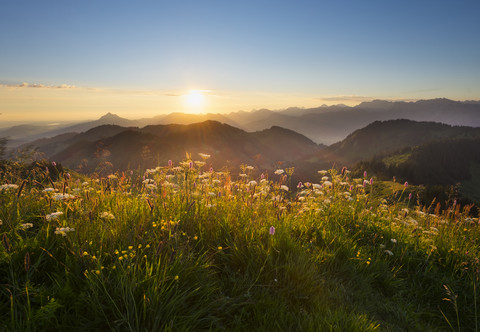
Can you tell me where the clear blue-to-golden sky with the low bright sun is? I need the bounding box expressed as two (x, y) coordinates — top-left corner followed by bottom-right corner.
(0, 0), (480, 123)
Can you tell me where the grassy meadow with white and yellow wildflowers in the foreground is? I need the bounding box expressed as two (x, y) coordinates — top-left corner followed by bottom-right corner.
(0, 154), (480, 331)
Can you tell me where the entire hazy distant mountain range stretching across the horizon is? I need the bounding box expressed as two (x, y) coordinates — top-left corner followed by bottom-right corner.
(0, 99), (480, 147)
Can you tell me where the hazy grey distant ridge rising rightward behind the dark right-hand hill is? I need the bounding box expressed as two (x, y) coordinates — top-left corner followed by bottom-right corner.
(242, 99), (480, 144)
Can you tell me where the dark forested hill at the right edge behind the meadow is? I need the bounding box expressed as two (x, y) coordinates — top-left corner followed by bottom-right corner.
(322, 120), (480, 204)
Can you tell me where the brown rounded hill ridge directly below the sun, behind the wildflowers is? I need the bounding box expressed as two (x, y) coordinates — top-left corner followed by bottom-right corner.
(35, 121), (321, 171)
